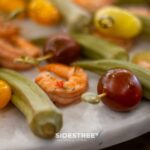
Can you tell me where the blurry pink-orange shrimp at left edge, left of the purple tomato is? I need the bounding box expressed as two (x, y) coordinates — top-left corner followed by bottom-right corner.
(0, 36), (41, 70)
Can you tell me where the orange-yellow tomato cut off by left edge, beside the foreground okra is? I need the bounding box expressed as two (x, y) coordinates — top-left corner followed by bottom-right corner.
(0, 80), (11, 109)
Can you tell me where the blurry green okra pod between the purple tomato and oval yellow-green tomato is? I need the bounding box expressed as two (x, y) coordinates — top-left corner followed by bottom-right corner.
(71, 33), (128, 60)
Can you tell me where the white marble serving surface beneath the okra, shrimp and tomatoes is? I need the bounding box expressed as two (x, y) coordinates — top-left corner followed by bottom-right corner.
(0, 20), (150, 150)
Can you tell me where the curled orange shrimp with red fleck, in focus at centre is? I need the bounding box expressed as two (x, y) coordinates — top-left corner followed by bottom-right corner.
(35, 64), (88, 106)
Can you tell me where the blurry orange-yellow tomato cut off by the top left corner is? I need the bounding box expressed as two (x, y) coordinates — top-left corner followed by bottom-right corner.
(0, 0), (26, 13)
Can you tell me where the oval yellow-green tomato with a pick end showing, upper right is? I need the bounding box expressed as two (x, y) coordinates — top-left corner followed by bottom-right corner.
(94, 6), (142, 38)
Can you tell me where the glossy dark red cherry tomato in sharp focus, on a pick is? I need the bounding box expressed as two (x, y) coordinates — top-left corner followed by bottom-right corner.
(97, 69), (142, 111)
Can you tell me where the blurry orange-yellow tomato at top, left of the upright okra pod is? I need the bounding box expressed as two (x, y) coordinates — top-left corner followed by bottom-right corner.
(28, 0), (60, 25)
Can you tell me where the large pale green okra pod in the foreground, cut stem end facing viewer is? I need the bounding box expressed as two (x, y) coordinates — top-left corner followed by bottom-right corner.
(0, 69), (62, 138)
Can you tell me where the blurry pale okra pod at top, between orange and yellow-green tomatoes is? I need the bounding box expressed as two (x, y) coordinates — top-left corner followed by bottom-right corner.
(50, 0), (92, 31)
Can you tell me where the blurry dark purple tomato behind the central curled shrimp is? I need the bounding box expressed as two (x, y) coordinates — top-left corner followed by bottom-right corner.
(44, 34), (80, 64)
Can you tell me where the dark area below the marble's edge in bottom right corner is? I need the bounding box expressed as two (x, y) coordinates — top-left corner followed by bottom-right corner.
(103, 133), (150, 150)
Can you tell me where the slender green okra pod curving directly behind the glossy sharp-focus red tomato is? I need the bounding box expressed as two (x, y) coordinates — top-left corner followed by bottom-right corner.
(74, 60), (150, 100)
